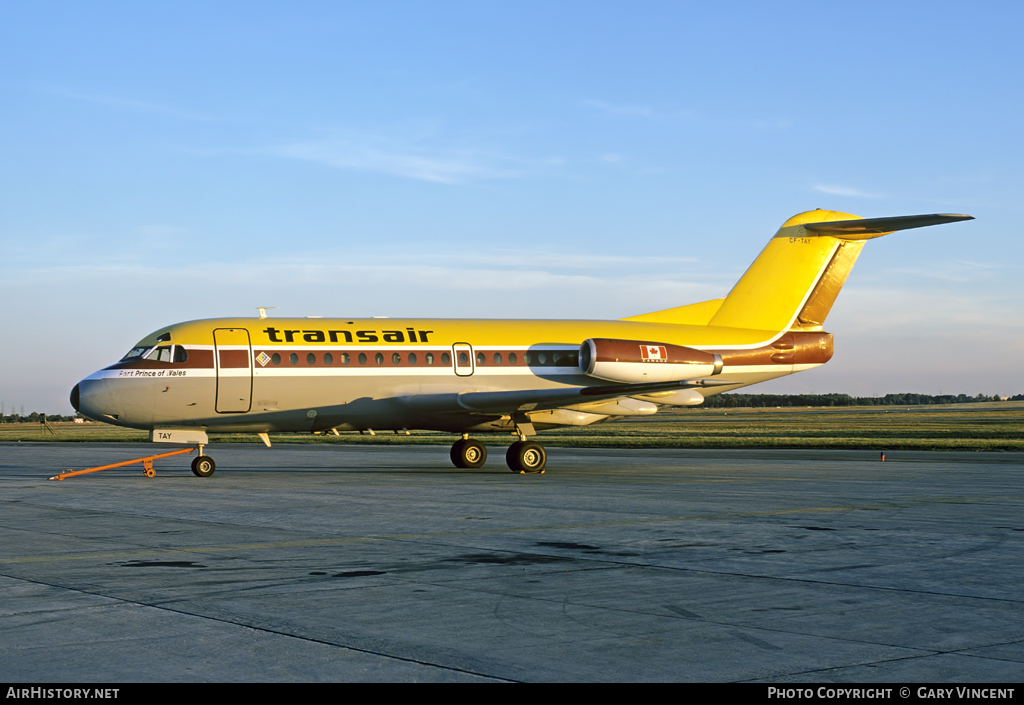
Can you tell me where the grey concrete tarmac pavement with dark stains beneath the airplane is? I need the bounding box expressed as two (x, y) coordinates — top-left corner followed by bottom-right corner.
(0, 443), (1024, 683)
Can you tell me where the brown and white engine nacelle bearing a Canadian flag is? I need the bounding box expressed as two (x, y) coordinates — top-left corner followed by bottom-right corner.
(580, 338), (722, 382)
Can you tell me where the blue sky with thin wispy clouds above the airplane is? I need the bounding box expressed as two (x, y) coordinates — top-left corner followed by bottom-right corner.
(0, 0), (1024, 413)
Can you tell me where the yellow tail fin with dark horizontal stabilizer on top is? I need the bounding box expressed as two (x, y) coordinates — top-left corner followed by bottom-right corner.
(708, 210), (973, 333)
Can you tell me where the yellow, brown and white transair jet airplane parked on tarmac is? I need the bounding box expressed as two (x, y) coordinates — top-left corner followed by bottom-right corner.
(71, 209), (973, 478)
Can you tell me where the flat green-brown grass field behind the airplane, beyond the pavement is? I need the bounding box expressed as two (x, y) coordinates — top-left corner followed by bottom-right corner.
(0, 402), (1024, 451)
